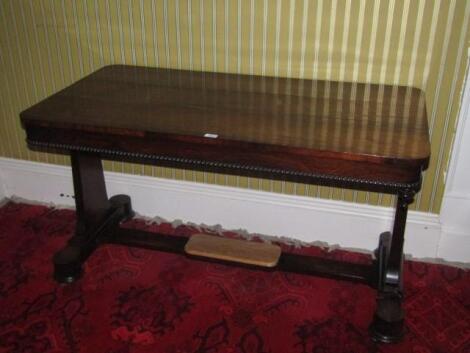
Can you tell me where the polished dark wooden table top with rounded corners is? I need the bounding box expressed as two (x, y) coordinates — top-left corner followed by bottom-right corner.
(21, 65), (430, 187)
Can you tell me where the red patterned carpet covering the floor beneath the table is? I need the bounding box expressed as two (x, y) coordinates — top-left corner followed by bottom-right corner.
(0, 203), (470, 353)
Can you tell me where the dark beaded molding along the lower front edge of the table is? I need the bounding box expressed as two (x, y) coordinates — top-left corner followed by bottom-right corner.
(26, 139), (421, 193)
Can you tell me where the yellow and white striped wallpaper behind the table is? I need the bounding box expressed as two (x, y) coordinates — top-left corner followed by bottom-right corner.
(0, 0), (470, 213)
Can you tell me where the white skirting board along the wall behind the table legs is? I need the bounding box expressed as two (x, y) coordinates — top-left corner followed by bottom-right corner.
(0, 158), (470, 262)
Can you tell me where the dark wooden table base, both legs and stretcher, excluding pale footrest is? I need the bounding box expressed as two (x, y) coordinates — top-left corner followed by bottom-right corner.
(54, 151), (416, 342)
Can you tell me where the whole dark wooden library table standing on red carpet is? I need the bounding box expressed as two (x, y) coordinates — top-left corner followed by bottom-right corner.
(20, 65), (430, 342)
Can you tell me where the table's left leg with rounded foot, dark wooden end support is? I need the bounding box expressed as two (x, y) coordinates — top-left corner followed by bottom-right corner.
(53, 151), (133, 283)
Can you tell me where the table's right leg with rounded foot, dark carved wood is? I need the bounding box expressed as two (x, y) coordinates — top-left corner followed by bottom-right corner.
(369, 190), (414, 342)
